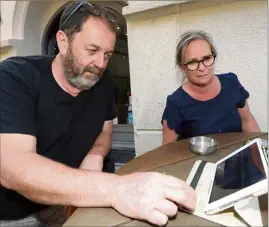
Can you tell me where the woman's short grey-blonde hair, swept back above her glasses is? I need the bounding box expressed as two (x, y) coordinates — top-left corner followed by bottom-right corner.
(176, 30), (217, 67)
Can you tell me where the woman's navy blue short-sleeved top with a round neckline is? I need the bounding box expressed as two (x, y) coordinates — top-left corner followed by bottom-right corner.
(162, 73), (249, 138)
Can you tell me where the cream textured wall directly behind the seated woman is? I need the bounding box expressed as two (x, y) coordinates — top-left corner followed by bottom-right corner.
(124, 1), (267, 155)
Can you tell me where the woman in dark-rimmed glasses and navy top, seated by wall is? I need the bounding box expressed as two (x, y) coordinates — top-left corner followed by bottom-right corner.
(162, 31), (260, 144)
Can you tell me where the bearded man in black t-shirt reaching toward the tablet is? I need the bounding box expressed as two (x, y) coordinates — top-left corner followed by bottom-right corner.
(0, 1), (196, 226)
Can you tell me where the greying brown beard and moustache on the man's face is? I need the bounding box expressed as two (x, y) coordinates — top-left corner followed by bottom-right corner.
(63, 46), (103, 91)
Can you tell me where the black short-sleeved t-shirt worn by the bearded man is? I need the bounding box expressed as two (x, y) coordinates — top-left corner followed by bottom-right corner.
(0, 56), (116, 220)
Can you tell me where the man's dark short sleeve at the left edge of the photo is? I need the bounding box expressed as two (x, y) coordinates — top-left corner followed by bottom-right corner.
(0, 62), (36, 136)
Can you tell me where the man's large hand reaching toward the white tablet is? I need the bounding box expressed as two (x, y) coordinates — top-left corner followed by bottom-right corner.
(112, 172), (196, 225)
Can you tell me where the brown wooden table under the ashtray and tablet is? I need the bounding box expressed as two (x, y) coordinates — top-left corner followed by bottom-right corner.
(64, 133), (268, 226)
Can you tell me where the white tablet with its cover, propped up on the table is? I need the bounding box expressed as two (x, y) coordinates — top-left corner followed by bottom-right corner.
(187, 139), (268, 214)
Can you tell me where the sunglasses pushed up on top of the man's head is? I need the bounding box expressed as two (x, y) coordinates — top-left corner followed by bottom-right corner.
(60, 1), (117, 30)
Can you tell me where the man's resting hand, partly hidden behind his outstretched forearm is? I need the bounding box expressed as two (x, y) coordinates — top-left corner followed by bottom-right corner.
(79, 153), (104, 172)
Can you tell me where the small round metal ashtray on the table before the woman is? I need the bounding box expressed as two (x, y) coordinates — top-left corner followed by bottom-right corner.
(189, 136), (217, 155)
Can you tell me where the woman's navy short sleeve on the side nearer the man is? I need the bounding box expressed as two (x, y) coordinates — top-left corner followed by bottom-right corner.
(162, 96), (182, 135)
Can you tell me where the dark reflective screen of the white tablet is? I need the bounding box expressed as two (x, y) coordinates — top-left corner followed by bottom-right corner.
(209, 143), (266, 203)
